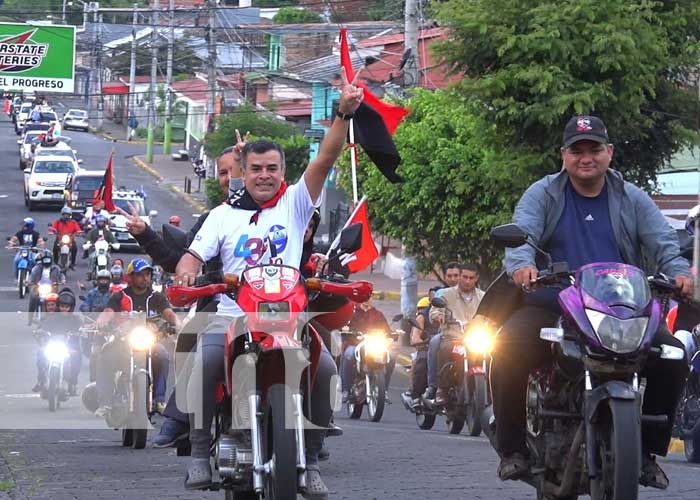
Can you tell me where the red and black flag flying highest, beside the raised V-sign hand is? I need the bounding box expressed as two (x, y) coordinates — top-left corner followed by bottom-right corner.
(340, 28), (409, 182)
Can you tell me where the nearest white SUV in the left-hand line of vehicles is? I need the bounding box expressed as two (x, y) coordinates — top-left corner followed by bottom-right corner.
(24, 156), (79, 210)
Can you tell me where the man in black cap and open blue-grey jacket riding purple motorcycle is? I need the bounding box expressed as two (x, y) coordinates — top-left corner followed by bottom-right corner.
(491, 116), (692, 489)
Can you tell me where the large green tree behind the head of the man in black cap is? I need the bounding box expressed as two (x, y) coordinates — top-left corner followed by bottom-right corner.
(436, 0), (700, 185)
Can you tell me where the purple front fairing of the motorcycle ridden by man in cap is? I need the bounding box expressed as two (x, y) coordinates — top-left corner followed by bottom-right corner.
(558, 262), (661, 357)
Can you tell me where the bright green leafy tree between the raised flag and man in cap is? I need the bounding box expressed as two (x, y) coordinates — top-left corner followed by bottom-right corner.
(339, 90), (526, 272)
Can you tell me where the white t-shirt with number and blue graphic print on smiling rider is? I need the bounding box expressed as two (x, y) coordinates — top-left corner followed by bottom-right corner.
(190, 178), (323, 316)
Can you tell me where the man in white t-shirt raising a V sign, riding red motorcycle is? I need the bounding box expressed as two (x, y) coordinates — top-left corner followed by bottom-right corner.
(175, 67), (363, 499)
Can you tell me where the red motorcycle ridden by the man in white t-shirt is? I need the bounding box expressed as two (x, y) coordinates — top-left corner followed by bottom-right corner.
(167, 227), (372, 500)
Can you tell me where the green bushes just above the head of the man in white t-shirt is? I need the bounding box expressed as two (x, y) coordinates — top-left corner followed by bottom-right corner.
(204, 104), (297, 157)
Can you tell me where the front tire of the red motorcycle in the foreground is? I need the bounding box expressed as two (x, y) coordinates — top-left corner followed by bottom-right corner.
(262, 384), (298, 500)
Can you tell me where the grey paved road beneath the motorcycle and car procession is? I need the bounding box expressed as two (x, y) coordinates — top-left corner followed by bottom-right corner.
(0, 113), (700, 500)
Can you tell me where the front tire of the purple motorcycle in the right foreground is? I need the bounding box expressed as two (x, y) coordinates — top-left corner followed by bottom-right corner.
(590, 399), (642, 500)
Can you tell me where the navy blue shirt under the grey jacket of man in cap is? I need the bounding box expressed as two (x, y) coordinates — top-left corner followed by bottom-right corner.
(545, 182), (623, 271)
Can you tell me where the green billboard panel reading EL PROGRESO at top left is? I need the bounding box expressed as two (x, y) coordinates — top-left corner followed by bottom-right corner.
(0, 23), (75, 93)
